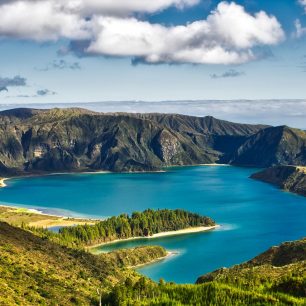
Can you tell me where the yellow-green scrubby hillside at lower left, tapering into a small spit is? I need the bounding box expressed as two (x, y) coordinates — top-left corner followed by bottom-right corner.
(0, 222), (166, 306)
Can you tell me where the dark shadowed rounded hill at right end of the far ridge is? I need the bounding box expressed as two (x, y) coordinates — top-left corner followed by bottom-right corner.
(229, 126), (306, 167)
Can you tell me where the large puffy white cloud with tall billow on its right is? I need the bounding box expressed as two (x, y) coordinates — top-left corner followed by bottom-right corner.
(87, 2), (284, 64)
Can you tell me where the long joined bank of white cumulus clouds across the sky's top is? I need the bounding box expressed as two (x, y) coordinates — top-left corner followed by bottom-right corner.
(0, 0), (284, 64)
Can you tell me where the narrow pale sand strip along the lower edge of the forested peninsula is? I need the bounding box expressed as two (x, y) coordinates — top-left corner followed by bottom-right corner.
(87, 225), (220, 249)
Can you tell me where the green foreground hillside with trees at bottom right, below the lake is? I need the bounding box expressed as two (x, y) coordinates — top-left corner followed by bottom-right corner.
(103, 239), (306, 306)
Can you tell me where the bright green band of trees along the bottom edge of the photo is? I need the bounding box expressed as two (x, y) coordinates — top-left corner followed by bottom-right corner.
(103, 276), (306, 306)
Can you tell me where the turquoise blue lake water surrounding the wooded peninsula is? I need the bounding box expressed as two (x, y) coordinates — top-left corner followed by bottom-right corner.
(0, 166), (306, 283)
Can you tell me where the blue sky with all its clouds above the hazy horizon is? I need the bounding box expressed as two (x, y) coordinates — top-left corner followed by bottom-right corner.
(0, 0), (306, 104)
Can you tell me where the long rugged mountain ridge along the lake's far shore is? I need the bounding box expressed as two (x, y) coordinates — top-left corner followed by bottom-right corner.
(0, 108), (306, 176)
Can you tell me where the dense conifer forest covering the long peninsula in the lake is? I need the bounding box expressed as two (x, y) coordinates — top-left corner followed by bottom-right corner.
(54, 209), (215, 246)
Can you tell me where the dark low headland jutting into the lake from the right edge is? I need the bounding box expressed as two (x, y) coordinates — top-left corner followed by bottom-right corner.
(251, 166), (306, 196)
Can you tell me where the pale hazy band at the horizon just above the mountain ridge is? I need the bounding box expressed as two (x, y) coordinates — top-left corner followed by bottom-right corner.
(0, 99), (306, 129)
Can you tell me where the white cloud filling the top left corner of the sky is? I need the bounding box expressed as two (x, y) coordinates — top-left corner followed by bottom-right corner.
(0, 1), (90, 41)
